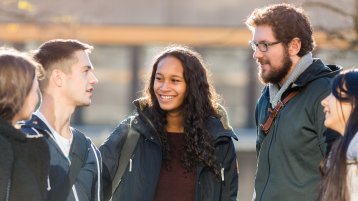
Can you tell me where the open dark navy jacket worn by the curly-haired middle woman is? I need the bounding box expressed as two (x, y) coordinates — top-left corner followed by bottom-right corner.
(99, 101), (238, 201)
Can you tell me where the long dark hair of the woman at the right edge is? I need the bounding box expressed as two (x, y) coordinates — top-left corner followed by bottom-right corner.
(317, 69), (358, 201)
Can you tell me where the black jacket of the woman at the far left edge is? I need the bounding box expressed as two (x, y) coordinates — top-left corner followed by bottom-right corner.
(0, 119), (50, 201)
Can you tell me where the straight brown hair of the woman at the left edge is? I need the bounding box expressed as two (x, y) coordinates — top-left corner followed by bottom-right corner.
(0, 47), (43, 122)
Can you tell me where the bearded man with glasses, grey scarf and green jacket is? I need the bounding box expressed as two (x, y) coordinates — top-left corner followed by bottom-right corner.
(246, 4), (341, 201)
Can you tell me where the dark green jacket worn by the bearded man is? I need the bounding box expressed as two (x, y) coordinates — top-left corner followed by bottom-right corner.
(253, 59), (341, 201)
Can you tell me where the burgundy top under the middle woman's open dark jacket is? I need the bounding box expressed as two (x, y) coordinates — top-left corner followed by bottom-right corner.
(154, 133), (195, 201)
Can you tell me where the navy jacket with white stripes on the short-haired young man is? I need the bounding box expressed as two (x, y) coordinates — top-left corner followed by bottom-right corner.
(21, 114), (102, 201)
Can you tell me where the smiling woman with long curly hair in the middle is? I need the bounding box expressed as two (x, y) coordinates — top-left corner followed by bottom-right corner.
(100, 46), (238, 201)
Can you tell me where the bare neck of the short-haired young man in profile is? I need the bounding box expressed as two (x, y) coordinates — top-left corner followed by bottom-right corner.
(39, 95), (75, 139)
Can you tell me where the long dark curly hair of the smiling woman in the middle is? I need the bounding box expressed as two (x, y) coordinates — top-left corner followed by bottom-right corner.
(140, 46), (220, 177)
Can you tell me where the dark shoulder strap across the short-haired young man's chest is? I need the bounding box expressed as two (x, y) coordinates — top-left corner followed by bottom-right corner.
(49, 129), (90, 201)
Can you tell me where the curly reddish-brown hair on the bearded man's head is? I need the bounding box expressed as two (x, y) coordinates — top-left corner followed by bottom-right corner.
(246, 4), (315, 57)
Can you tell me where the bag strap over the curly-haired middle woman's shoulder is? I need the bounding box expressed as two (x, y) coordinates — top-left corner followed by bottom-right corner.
(112, 118), (140, 196)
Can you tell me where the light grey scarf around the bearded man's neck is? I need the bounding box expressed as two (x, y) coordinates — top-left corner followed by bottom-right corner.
(268, 52), (313, 108)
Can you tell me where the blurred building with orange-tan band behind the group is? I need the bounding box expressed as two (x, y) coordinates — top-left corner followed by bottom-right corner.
(0, 0), (358, 201)
